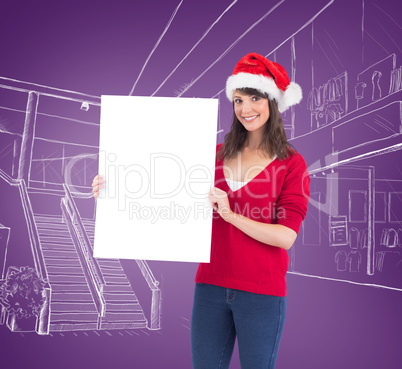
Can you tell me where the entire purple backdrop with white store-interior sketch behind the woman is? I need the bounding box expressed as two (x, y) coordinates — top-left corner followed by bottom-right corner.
(0, 0), (402, 369)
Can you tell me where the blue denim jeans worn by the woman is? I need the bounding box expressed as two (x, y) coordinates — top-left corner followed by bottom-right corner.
(191, 283), (286, 369)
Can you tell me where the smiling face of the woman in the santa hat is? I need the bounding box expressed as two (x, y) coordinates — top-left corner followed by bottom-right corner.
(233, 90), (269, 132)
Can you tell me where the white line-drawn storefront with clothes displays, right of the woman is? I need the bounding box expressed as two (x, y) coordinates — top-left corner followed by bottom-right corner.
(291, 54), (402, 291)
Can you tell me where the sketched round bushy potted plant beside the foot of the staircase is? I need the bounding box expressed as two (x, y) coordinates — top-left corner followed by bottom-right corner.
(0, 267), (45, 332)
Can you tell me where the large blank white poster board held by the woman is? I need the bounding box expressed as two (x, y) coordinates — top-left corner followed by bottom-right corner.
(94, 96), (218, 262)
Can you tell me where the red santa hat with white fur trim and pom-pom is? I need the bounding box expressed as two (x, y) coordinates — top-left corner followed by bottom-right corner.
(226, 53), (302, 113)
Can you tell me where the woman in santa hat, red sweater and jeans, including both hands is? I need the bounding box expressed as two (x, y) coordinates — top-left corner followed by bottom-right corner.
(92, 53), (310, 369)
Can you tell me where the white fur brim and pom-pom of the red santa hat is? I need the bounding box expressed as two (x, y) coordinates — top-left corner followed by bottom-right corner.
(226, 73), (302, 113)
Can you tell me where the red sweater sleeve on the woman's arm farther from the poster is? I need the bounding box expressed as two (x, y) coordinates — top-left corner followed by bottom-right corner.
(276, 154), (310, 233)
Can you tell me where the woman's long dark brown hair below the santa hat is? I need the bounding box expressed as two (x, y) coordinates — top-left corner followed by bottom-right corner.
(218, 88), (296, 160)
